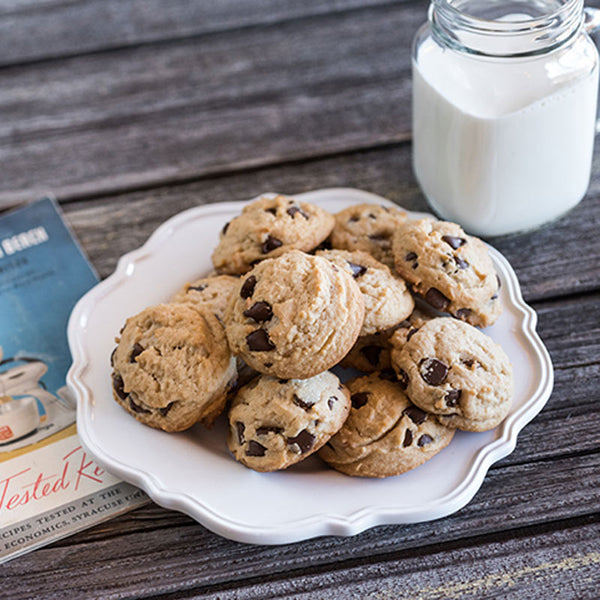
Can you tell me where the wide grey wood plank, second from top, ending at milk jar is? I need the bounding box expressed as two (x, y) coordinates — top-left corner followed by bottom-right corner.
(0, 3), (425, 206)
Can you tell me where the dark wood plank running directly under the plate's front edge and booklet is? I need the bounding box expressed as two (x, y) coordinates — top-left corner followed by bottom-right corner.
(0, 455), (600, 599)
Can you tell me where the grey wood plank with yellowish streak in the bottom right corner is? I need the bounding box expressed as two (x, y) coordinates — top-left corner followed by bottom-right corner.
(168, 522), (600, 600)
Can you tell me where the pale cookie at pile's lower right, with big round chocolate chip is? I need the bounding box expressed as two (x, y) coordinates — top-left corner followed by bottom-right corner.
(392, 318), (513, 431)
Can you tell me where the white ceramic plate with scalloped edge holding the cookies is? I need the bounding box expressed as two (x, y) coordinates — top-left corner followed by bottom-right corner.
(68, 188), (553, 544)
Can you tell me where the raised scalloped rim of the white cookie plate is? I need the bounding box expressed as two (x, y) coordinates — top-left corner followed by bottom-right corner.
(67, 187), (554, 544)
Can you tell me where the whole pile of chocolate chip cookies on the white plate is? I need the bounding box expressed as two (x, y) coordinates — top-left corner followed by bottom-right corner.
(111, 196), (512, 477)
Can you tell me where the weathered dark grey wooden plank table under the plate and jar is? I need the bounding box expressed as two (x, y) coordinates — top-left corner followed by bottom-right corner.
(0, 0), (600, 600)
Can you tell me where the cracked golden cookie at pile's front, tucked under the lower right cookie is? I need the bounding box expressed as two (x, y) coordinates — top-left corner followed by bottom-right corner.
(319, 373), (454, 477)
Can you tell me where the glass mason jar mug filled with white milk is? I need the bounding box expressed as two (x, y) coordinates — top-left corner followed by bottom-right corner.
(413, 0), (599, 235)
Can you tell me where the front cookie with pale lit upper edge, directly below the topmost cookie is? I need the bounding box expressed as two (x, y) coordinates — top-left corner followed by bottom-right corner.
(227, 371), (350, 471)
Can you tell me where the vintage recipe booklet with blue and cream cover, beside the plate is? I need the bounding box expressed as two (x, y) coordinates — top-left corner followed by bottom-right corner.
(0, 198), (148, 562)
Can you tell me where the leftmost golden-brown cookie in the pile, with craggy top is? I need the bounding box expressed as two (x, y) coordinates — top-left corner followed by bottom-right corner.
(111, 304), (236, 431)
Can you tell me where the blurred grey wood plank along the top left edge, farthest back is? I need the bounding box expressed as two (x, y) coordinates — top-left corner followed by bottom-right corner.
(0, 0), (414, 67)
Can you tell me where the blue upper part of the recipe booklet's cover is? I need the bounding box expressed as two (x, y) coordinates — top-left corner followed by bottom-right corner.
(0, 198), (98, 408)
